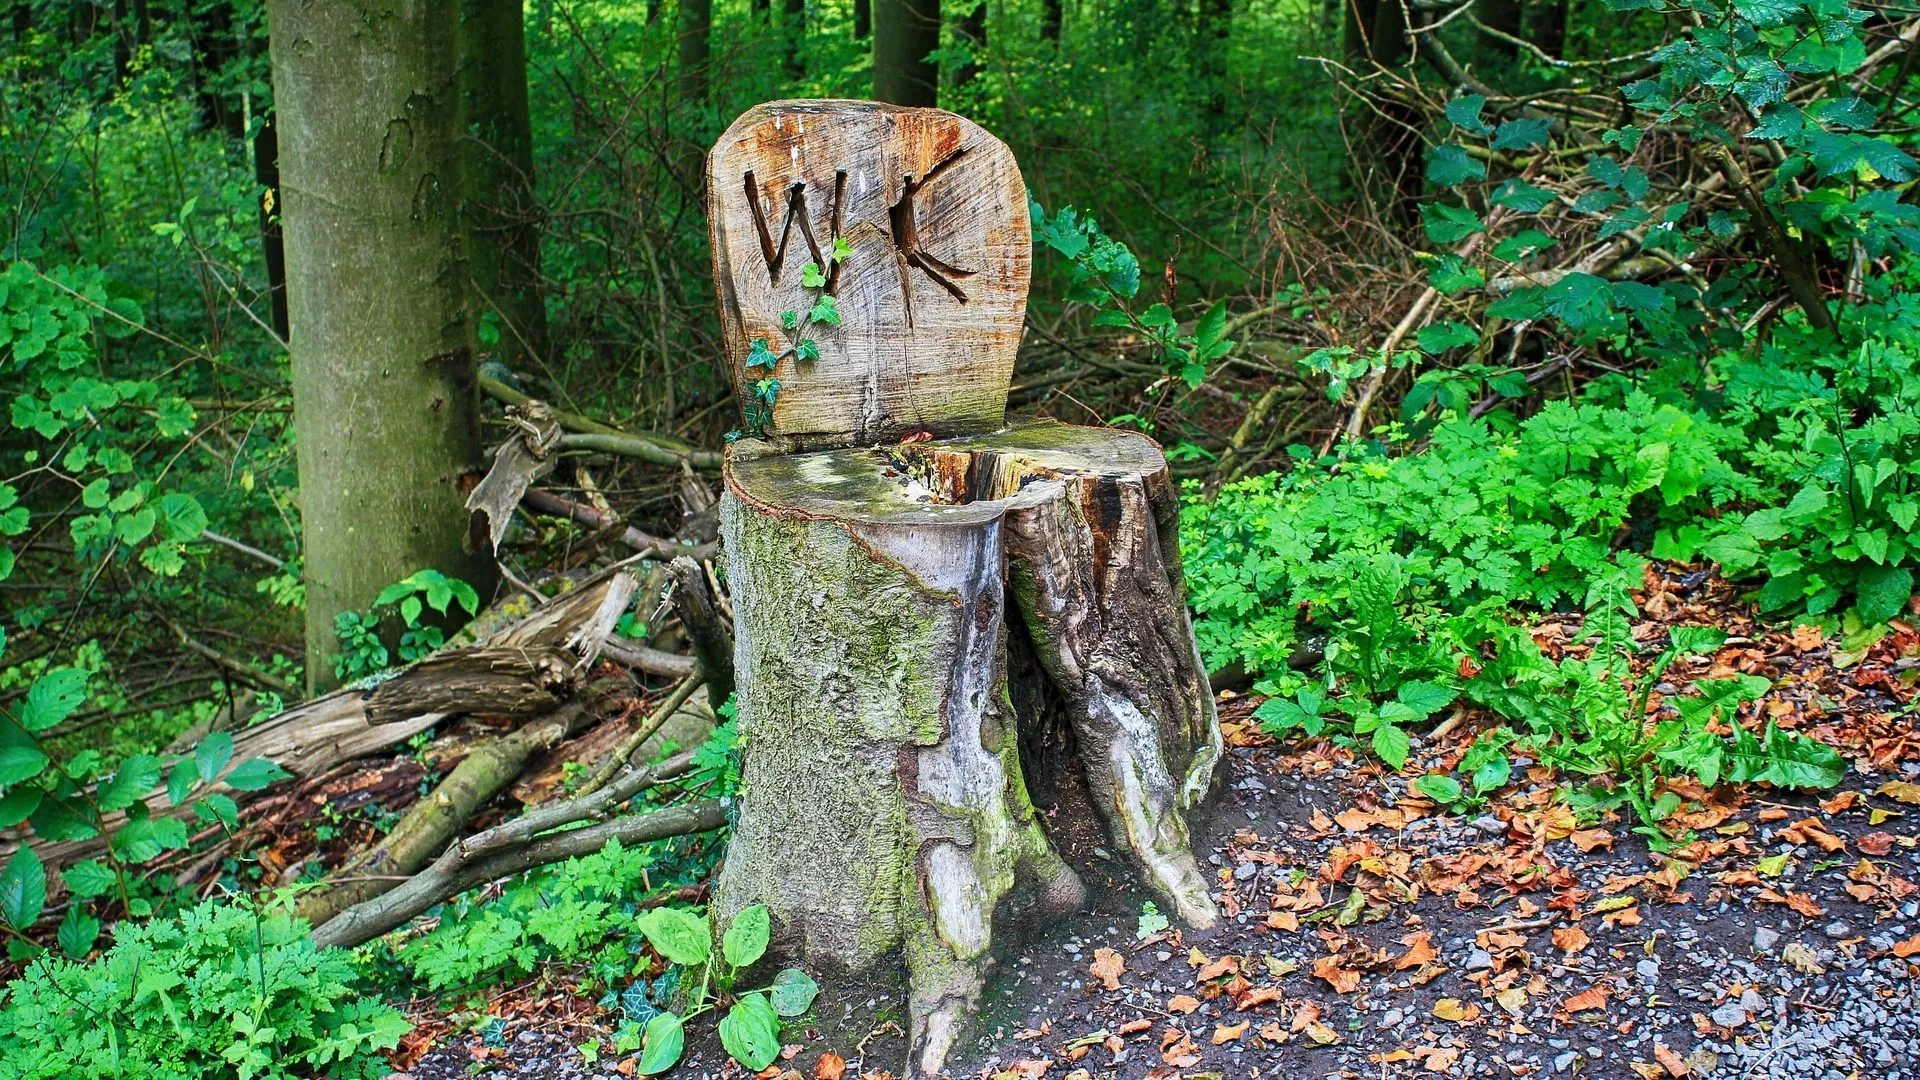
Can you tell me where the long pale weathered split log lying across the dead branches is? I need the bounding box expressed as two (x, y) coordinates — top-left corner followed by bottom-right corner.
(0, 571), (639, 869)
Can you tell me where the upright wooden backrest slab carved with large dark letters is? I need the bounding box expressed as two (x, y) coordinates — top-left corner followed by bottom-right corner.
(707, 100), (1033, 446)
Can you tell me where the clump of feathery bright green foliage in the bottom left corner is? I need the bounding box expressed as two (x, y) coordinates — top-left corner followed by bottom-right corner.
(0, 901), (409, 1080)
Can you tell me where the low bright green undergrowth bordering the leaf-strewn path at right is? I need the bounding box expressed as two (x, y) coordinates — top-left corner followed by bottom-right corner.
(1183, 271), (1920, 822)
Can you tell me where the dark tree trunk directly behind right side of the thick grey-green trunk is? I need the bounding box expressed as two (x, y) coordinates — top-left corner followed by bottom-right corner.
(459, 0), (547, 371)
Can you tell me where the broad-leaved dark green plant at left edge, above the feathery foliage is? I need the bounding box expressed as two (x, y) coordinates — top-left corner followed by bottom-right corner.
(0, 638), (288, 959)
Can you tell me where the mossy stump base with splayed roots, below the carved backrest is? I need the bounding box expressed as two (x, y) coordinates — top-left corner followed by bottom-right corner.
(716, 421), (1219, 1076)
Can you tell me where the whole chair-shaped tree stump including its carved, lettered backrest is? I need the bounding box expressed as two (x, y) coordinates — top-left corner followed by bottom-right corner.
(708, 102), (1219, 1076)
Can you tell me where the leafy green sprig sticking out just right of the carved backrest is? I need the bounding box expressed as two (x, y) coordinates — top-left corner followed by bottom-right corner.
(1027, 200), (1236, 388)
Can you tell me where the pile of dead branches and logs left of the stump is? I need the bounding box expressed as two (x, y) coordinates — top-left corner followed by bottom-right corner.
(8, 402), (733, 945)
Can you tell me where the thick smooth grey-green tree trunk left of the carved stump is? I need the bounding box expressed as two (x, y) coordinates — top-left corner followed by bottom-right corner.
(269, 0), (493, 686)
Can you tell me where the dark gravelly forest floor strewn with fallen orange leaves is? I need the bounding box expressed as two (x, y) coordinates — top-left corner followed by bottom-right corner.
(385, 575), (1920, 1080)
